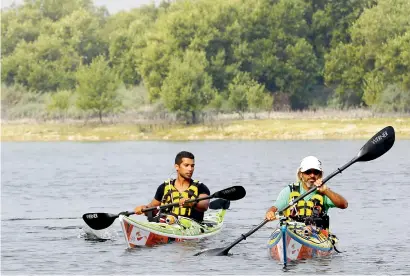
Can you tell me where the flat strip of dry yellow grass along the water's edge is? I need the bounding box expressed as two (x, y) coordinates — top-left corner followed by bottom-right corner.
(1, 117), (410, 142)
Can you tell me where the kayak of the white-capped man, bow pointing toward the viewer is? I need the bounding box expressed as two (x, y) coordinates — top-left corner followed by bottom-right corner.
(267, 221), (338, 265)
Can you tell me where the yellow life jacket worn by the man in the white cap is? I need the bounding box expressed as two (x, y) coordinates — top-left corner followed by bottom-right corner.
(284, 182), (324, 220)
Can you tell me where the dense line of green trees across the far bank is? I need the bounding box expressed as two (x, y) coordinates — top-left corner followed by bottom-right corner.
(1, 0), (410, 123)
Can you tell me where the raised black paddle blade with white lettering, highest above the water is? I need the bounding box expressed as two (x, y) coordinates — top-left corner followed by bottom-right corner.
(357, 126), (396, 162)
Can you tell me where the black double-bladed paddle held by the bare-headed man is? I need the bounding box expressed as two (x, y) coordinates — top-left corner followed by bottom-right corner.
(83, 186), (246, 230)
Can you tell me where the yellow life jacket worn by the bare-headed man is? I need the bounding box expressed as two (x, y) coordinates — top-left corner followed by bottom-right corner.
(161, 179), (200, 217)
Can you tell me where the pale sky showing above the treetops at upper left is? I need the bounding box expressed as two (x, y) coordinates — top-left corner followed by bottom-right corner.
(0, 0), (160, 14)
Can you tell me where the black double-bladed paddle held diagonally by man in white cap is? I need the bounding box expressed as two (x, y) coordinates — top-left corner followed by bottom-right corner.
(195, 126), (395, 256)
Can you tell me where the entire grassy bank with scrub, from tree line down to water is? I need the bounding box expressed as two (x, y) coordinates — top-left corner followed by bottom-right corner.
(1, 83), (410, 141)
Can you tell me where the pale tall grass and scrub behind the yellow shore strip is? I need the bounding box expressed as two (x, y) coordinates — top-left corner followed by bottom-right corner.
(1, 85), (409, 125)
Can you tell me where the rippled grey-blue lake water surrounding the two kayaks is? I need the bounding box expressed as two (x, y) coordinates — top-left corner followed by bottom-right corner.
(1, 141), (410, 275)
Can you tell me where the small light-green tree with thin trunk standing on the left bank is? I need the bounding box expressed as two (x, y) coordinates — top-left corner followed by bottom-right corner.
(76, 56), (121, 122)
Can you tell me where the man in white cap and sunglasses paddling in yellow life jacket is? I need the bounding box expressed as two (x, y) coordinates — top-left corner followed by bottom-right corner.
(265, 156), (348, 224)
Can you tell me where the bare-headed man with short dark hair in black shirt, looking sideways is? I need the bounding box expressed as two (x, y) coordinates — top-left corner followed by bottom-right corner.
(134, 151), (211, 222)
